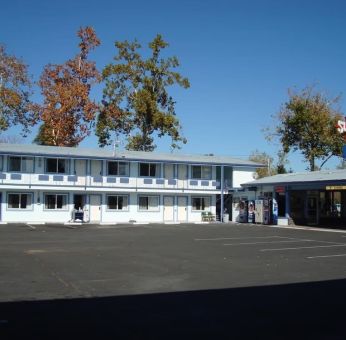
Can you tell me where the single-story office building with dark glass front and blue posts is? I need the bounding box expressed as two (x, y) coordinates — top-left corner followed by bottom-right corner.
(233, 170), (346, 227)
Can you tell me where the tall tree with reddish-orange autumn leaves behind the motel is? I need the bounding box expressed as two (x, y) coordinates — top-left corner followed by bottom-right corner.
(34, 27), (100, 146)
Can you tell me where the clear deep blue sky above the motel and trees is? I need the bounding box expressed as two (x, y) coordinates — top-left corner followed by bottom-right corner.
(0, 0), (346, 171)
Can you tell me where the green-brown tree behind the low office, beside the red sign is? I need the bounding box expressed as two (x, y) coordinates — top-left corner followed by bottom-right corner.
(267, 86), (344, 171)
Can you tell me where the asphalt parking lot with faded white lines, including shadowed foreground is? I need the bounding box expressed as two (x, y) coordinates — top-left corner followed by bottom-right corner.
(0, 224), (346, 339)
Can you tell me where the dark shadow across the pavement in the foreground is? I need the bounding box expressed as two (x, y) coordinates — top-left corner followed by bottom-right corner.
(0, 280), (346, 339)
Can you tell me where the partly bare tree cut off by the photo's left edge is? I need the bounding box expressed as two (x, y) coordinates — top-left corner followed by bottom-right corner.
(0, 45), (38, 137)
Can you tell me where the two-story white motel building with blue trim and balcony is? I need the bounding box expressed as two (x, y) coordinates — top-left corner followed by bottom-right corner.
(0, 144), (258, 224)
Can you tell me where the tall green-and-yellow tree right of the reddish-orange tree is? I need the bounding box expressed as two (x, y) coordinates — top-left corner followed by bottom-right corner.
(96, 35), (190, 151)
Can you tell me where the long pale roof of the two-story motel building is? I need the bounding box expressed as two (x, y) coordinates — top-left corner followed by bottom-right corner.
(0, 143), (264, 168)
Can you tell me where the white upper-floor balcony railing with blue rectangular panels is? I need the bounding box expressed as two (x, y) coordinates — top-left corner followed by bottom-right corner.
(0, 173), (220, 190)
